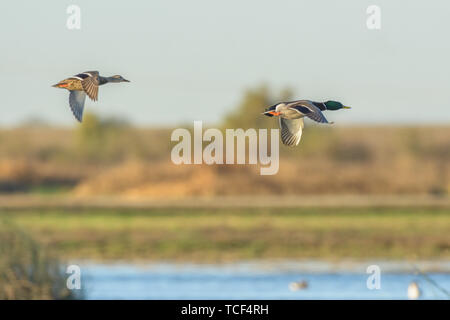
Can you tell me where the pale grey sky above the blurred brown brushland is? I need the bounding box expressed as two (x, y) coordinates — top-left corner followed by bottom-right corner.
(0, 0), (450, 126)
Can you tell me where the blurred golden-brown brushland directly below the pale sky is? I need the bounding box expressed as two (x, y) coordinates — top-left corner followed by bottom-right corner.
(0, 124), (450, 199)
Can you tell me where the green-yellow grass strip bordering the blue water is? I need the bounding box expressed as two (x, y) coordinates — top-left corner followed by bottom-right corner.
(0, 207), (450, 262)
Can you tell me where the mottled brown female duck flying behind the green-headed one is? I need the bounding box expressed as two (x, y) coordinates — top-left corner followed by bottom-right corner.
(53, 71), (130, 122)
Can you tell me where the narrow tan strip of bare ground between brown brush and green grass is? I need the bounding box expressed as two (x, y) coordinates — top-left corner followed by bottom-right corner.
(0, 194), (450, 209)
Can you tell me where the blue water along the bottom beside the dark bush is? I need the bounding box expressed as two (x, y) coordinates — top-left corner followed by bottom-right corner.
(79, 263), (450, 299)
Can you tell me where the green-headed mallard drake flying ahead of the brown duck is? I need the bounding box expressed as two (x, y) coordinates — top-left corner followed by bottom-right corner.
(263, 100), (350, 146)
